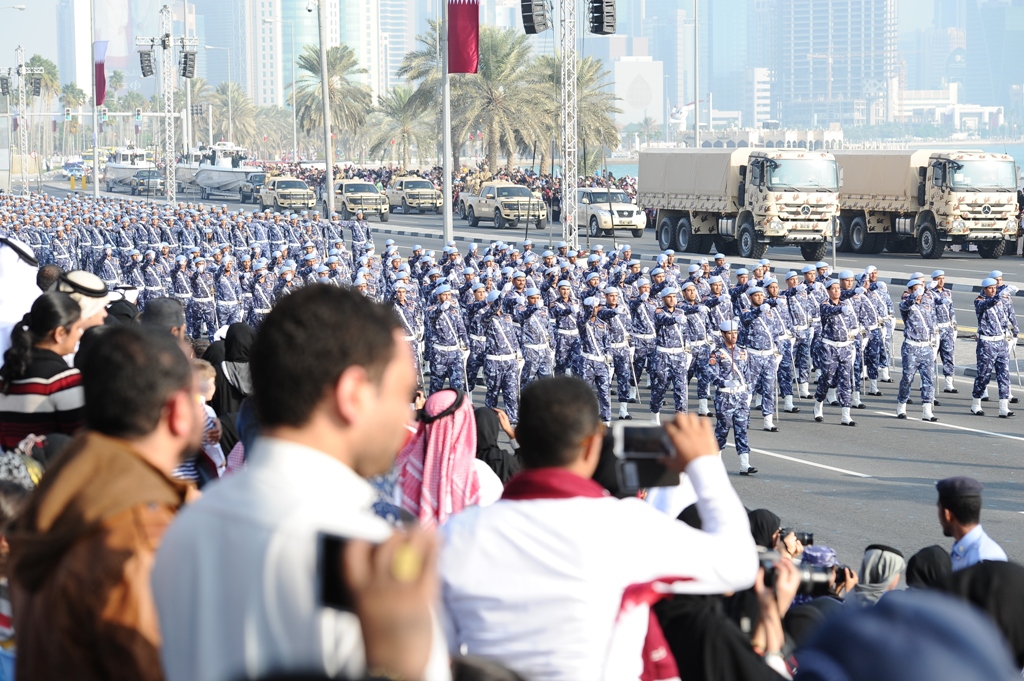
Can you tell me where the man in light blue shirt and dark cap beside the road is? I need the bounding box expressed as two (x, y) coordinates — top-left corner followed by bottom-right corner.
(935, 477), (1007, 571)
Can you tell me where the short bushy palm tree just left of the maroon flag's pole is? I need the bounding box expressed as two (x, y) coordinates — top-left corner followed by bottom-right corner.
(367, 85), (436, 168)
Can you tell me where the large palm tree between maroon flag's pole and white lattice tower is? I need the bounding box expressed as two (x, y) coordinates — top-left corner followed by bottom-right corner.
(453, 26), (545, 172)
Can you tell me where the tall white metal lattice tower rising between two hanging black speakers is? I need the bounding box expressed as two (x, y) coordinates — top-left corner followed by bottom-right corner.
(561, 0), (580, 249)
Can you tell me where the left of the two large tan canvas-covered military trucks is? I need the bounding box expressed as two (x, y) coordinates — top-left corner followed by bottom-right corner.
(637, 148), (841, 261)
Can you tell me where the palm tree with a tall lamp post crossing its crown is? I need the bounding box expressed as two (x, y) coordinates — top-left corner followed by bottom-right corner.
(295, 45), (373, 140)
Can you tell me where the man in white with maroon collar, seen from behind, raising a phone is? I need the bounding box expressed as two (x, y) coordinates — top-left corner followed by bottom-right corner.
(439, 378), (758, 681)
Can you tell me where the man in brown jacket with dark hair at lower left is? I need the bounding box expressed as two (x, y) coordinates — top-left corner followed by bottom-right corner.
(7, 327), (205, 681)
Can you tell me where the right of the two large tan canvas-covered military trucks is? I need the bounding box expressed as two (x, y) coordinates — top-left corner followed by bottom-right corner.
(835, 150), (1017, 258)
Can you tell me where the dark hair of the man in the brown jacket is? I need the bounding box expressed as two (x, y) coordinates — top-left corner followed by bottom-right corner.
(79, 326), (193, 438)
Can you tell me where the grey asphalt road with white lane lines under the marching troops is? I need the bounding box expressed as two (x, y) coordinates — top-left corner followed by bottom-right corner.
(51, 180), (1024, 570)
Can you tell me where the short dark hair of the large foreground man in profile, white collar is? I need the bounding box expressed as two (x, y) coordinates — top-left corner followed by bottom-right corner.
(249, 286), (400, 427)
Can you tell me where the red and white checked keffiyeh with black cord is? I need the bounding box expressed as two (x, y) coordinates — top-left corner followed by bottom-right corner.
(395, 390), (480, 527)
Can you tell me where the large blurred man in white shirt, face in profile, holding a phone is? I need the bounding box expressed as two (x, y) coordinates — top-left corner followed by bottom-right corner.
(153, 286), (451, 681)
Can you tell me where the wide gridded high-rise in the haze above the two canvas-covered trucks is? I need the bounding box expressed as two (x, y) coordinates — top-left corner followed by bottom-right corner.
(773, 0), (897, 127)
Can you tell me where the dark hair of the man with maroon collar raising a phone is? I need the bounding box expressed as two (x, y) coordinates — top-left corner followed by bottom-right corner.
(515, 376), (601, 468)
